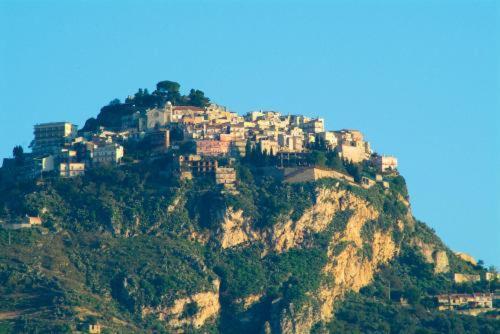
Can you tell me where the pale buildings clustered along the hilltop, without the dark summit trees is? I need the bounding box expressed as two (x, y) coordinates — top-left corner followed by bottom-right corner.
(3, 102), (397, 184)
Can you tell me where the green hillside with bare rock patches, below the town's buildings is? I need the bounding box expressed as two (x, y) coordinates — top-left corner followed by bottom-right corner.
(0, 81), (500, 333)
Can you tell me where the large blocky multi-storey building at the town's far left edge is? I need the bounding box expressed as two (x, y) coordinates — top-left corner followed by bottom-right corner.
(31, 122), (77, 155)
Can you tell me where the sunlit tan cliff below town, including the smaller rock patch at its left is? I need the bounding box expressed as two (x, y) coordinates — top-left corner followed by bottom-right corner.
(219, 187), (404, 333)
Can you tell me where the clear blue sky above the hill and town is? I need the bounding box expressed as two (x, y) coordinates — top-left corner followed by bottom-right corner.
(0, 0), (500, 266)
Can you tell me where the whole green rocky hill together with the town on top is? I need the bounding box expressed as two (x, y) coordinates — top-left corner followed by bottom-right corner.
(0, 81), (500, 334)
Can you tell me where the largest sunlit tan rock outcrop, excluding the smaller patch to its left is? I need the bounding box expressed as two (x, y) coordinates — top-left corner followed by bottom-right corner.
(272, 189), (403, 333)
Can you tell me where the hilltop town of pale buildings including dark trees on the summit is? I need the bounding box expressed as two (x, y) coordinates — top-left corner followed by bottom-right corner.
(2, 81), (398, 186)
